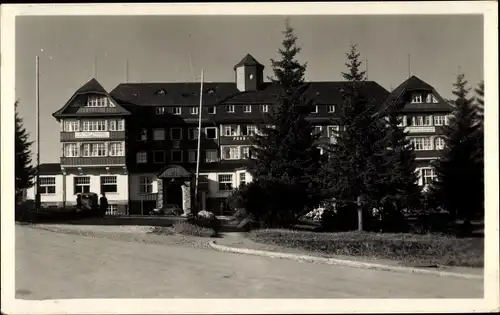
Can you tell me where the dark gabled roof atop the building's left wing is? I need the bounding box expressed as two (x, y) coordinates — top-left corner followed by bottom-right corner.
(52, 78), (130, 118)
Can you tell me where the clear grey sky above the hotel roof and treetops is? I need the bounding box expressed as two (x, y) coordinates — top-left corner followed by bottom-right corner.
(15, 15), (483, 163)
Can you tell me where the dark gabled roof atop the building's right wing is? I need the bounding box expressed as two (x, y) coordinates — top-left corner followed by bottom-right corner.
(382, 75), (453, 112)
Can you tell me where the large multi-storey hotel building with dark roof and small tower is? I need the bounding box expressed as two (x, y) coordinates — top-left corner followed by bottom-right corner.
(28, 55), (452, 214)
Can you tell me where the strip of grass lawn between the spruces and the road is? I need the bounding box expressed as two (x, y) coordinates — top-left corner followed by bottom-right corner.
(248, 229), (484, 267)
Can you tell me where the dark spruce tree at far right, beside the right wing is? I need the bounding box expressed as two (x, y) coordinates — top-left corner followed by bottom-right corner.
(431, 74), (484, 232)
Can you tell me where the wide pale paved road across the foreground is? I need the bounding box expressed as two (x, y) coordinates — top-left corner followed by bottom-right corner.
(16, 226), (483, 299)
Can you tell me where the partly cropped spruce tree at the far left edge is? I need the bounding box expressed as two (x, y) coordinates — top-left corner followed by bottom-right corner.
(14, 101), (36, 202)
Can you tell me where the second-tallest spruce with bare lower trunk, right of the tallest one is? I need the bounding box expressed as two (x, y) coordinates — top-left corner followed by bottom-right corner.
(322, 45), (387, 229)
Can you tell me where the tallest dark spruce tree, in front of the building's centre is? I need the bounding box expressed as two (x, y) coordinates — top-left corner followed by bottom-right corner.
(244, 21), (320, 227)
